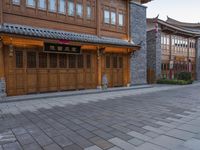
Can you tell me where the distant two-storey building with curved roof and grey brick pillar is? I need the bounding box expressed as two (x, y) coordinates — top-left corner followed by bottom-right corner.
(147, 18), (200, 83)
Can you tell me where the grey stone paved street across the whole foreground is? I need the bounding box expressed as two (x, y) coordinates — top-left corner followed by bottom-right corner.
(0, 83), (200, 150)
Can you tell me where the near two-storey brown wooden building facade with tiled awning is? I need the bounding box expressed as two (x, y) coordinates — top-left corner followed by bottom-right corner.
(0, 0), (148, 96)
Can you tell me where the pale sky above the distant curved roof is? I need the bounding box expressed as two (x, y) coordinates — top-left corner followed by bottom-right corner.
(145, 0), (200, 23)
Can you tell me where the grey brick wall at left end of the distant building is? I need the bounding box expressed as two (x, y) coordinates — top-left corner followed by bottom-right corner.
(147, 30), (162, 80)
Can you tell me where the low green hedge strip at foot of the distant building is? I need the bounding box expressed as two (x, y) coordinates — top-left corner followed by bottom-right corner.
(157, 79), (193, 85)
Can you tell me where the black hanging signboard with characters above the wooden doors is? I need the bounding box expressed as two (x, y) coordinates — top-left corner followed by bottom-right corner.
(44, 43), (81, 54)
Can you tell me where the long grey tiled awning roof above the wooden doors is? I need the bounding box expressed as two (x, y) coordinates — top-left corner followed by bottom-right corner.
(0, 23), (136, 47)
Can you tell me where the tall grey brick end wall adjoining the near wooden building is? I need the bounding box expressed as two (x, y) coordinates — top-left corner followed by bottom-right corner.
(130, 2), (147, 85)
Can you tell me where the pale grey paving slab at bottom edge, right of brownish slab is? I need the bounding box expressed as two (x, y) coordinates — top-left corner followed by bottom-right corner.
(109, 138), (135, 150)
